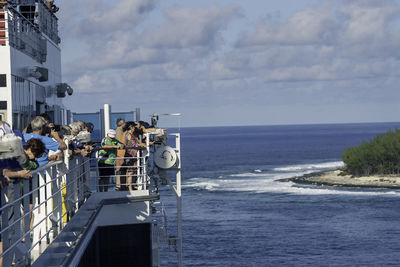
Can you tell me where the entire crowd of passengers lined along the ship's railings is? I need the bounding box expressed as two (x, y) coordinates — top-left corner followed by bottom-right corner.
(0, 114), (158, 266)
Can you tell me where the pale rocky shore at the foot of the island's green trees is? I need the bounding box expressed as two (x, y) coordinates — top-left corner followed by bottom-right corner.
(280, 170), (400, 189)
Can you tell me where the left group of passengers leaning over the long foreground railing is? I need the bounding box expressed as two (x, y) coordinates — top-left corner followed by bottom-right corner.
(0, 114), (94, 187)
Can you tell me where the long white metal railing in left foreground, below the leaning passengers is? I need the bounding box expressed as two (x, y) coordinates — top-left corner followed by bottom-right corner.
(0, 156), (90, 266)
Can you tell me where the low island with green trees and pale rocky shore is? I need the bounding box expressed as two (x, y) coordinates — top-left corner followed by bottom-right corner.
(283, 129), (400, 189)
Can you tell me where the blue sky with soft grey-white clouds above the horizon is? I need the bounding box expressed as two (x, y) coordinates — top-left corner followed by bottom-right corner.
(55, 0), (400, 127)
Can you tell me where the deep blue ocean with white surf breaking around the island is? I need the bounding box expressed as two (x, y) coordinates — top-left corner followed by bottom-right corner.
(168, 123), (400, 266)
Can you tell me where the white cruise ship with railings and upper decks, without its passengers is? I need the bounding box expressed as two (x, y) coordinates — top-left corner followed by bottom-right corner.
(0, 0), (183, 266)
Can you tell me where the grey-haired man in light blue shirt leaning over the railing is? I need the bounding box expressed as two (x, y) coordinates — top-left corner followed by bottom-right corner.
(24, 116), (67, 167)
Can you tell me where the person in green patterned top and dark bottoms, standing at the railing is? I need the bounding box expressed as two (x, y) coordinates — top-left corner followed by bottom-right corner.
(97, 129), (124, 192)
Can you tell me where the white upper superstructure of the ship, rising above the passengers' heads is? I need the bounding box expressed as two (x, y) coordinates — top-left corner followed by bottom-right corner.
(0, 0), (73, 129)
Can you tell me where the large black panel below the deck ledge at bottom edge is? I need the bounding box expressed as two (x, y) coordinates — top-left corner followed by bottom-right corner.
(78, 223), (152, 267)
